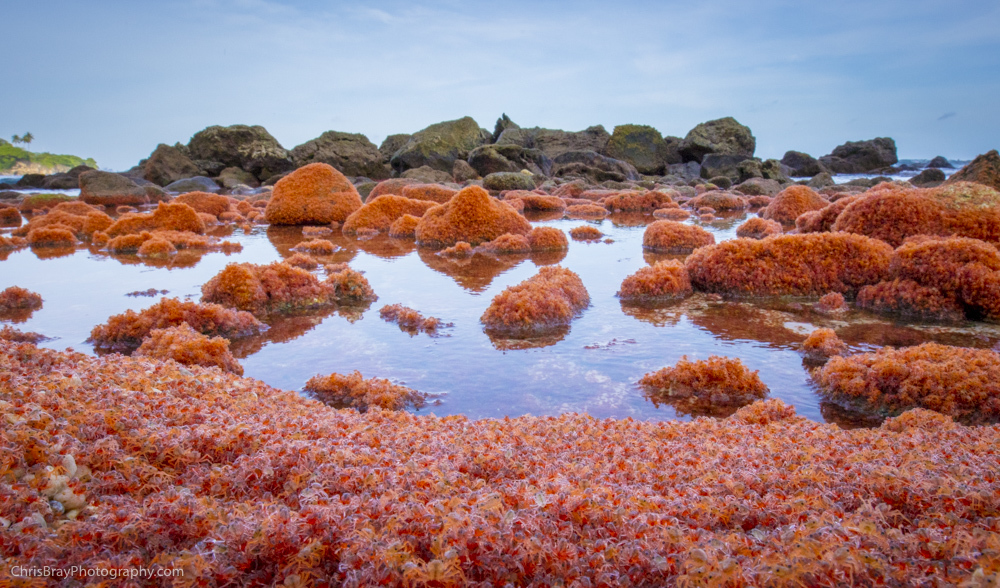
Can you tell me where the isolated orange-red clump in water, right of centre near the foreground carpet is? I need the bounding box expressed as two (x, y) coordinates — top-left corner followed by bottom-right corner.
(639, 355), (768, 413)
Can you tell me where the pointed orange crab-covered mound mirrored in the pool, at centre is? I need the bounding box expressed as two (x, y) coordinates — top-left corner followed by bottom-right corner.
(416, 186), (531, 247)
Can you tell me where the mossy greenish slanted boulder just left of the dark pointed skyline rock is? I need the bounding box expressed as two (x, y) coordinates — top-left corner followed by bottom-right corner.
(390, 116), (493, 176)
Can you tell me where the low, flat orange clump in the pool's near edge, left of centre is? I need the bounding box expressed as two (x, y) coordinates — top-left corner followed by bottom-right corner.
(304, 371), (427, 412)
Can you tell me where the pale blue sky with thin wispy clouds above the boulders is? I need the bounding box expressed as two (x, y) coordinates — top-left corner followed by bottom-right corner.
(0, 0), (1000, 170)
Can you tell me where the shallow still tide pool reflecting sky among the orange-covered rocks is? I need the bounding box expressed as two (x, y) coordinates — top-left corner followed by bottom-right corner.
(0, 209), (1000, 426)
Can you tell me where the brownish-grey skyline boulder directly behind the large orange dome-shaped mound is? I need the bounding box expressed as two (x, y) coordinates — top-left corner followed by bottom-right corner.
(292, 131), (389, 180)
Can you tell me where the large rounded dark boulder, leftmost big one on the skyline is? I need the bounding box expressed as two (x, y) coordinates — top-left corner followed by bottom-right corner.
(188, 125), (295, 180)
